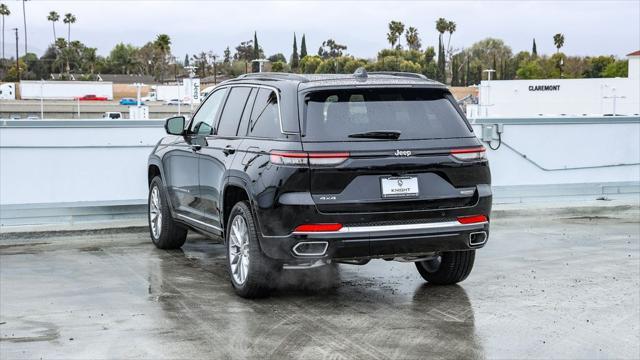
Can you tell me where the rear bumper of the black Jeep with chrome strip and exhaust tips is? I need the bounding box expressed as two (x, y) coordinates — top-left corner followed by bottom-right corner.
(261, 221), (489, 263)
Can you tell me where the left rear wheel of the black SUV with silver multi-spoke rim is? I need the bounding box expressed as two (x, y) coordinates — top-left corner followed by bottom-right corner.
(225, 201), (278, 299)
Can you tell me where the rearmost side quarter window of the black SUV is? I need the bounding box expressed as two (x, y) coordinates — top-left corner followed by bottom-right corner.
(249, 89), (282, 138)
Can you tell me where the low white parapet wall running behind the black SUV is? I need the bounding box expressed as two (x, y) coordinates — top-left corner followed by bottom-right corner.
(0, 117), (640, 225)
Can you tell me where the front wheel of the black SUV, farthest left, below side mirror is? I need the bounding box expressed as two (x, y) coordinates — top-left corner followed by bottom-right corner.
(147, 176), (187, 250)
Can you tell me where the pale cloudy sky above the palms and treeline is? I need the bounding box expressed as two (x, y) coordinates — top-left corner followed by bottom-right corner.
(0, 0), (640, 58)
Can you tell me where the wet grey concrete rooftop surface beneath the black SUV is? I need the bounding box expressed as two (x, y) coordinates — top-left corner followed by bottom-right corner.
(0, 211), (640, 359)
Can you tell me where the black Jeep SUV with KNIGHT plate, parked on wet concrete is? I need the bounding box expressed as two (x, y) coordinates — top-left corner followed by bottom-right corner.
(148, 69), (491, 297)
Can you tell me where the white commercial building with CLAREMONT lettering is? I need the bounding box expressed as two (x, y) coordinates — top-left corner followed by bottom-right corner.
(467, 51), (640, 119)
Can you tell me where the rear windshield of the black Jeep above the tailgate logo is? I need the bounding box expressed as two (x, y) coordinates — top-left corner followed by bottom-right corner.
(305, 88), (473, 141)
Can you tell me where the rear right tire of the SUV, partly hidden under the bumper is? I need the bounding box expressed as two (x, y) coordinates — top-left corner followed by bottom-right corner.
(416, 250), (476, 285)
